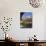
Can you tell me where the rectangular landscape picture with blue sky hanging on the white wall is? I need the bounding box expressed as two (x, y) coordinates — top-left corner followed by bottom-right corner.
(20, 12), (32, 28)
